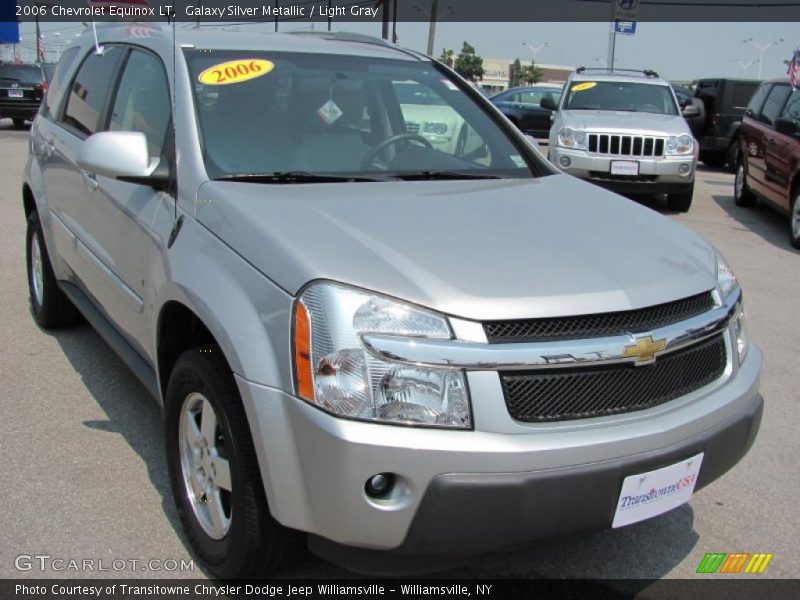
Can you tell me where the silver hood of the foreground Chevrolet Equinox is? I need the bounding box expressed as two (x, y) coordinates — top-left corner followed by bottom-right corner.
(196, 175), (716, 320)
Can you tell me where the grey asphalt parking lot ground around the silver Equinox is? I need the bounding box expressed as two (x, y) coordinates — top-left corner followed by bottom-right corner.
(0, 120), (800, 579)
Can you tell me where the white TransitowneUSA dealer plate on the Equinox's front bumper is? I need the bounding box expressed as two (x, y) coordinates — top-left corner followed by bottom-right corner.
(611, 452), (703, 527)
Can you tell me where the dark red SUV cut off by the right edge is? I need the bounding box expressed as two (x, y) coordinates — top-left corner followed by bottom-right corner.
(734, 78), (800, 248)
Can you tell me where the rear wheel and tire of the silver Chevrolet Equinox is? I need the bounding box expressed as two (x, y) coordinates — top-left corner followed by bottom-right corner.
(25, 212), (80, 329)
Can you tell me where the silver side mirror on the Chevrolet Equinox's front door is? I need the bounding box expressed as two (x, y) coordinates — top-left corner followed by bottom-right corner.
(77, 131), (170, 190)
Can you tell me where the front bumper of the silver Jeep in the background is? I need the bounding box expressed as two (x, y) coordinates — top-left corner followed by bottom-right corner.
(549, 145), (697, 194)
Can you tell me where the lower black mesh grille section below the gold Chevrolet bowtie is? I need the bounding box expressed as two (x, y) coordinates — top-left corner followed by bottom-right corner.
(500, 334), (727, 423)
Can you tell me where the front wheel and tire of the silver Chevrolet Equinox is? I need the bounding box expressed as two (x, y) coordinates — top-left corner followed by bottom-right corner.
(165, 346), (302, 579)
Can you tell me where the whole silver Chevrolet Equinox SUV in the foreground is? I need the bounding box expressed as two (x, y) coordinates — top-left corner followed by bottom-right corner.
(22, 25), (763, 577)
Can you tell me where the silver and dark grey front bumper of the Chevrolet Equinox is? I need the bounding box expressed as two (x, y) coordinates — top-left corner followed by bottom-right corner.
(237, 332), (762, 566)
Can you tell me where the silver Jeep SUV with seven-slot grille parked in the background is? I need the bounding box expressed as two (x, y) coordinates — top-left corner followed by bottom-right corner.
(549, 68), (698, 212)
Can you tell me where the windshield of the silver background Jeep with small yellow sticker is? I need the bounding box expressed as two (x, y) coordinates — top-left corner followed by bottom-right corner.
(564, 81), (678, 116)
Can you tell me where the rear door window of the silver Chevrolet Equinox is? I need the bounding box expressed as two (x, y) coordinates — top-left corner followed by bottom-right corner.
(64, 46), (125, 135)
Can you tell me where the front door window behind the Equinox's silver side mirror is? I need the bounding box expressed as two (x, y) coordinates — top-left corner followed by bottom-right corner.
(109, 50), (172, 157)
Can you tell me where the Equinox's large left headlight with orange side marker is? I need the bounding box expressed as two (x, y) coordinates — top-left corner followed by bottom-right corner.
(294, 282), (472, 429)
